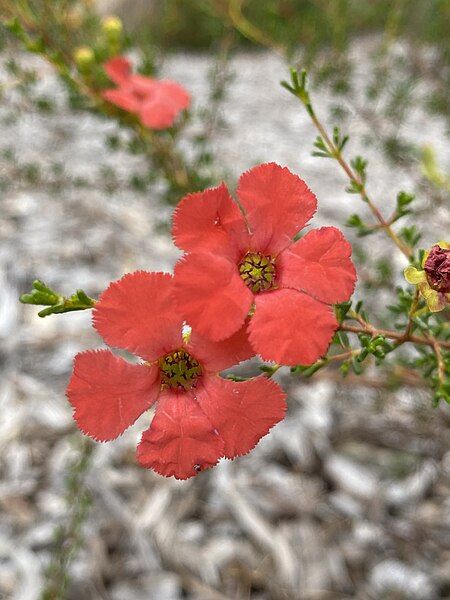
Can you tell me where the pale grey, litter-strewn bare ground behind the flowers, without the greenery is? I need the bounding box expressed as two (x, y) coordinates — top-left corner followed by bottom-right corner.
(0, 54), (450, 600)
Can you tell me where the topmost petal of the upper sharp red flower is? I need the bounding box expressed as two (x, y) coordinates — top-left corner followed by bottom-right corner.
(237, 163), (317, 254)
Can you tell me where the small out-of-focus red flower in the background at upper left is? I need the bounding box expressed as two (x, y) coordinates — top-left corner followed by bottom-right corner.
(102, 56), (190, 129)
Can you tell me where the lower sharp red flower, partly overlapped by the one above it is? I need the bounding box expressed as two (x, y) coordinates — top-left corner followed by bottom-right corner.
(67, 271), (286, 479)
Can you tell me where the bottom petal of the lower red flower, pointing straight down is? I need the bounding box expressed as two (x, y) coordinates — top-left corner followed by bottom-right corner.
(137, 390), (223, 479)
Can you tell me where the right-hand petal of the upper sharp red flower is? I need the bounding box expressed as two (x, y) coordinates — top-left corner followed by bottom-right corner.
(279, 227), (356, 304)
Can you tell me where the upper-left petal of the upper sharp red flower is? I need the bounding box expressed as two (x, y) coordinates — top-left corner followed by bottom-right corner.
(172, 184), (248, 260)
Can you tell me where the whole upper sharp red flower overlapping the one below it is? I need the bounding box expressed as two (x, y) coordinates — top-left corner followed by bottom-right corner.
(173, 163), (356, 365)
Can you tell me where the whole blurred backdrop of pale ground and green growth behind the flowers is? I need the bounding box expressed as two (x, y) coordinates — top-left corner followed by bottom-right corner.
(0, 0), (450, 600)
